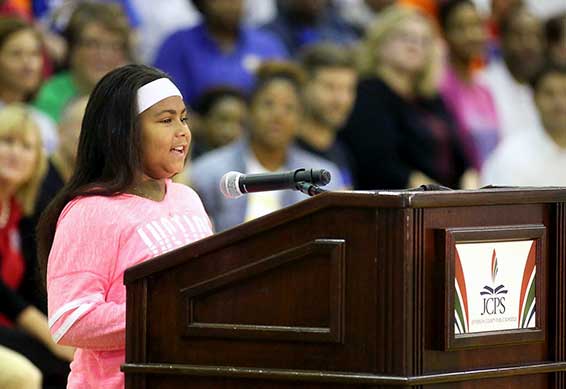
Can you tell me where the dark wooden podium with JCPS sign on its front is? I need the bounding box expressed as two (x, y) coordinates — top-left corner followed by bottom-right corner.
(122, 188), (566, 389)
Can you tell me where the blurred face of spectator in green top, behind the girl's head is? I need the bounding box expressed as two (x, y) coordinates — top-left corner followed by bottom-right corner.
(71, 22), (128, 87)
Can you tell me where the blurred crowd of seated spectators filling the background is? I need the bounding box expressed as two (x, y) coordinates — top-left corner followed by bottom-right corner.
(0, 0), (566, 388)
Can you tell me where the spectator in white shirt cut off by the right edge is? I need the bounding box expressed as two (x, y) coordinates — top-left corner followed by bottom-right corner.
(482, 64), (566, 186)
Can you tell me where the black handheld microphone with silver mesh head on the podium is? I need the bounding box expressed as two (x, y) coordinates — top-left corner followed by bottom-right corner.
(220, 169), (331, 199)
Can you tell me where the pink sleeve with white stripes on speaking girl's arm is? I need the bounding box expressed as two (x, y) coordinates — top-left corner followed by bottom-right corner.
(47, 198), (126, 351)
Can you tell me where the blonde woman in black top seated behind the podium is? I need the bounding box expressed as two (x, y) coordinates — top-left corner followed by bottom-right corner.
(338, 6), (468, 190)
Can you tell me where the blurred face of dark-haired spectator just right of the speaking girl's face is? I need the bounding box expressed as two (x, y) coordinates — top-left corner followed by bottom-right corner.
(205, 96), (248, 147)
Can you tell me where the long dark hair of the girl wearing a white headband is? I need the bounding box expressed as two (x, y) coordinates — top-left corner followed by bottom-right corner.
(37, 65), (169, 275)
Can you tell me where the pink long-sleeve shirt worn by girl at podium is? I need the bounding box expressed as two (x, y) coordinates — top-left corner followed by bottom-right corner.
(47, 180), (212, 389)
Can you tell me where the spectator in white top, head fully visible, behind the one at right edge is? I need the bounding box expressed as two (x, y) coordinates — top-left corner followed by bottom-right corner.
(481, 6), (544, 137)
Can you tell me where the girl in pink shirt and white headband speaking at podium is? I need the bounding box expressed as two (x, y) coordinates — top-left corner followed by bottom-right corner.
(38, 65), (212, 388)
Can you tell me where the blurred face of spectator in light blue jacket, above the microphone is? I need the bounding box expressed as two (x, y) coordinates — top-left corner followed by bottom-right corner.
(250, 79), (301, 150)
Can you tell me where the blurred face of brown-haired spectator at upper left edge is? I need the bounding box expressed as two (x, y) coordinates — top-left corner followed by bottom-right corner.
(0, 29), (43, 94)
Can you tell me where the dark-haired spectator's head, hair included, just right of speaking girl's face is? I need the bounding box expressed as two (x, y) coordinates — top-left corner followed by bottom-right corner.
(191, 87), (248, 159)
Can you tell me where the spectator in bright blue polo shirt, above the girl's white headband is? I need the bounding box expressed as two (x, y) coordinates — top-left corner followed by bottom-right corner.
(154, 0), (287, 104)
